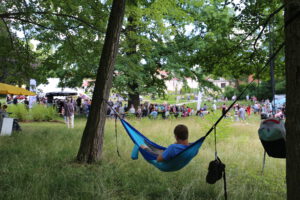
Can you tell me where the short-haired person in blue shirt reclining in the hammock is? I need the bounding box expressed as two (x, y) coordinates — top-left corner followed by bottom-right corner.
(140, 124), (189, 162)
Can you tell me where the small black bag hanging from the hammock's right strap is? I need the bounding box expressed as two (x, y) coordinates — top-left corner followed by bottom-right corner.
(206, 158), (225, 184)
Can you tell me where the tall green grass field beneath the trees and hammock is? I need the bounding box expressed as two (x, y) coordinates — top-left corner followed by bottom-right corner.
(0, 115), (286, 200)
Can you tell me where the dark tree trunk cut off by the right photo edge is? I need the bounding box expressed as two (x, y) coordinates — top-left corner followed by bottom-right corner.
(285, 0), (300, 200)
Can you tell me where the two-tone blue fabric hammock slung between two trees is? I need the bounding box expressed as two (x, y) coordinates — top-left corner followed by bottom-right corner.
(120, 119), (206, 172)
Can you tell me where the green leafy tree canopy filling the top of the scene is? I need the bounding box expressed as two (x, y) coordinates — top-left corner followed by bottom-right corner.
(0, 0), (284, 103)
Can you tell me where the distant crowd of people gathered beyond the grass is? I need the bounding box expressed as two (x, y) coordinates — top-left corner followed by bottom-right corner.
(0, 93), (285, 128)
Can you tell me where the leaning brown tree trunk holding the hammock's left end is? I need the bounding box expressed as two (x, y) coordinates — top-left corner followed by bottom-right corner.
(77, 0), (125, 163)
